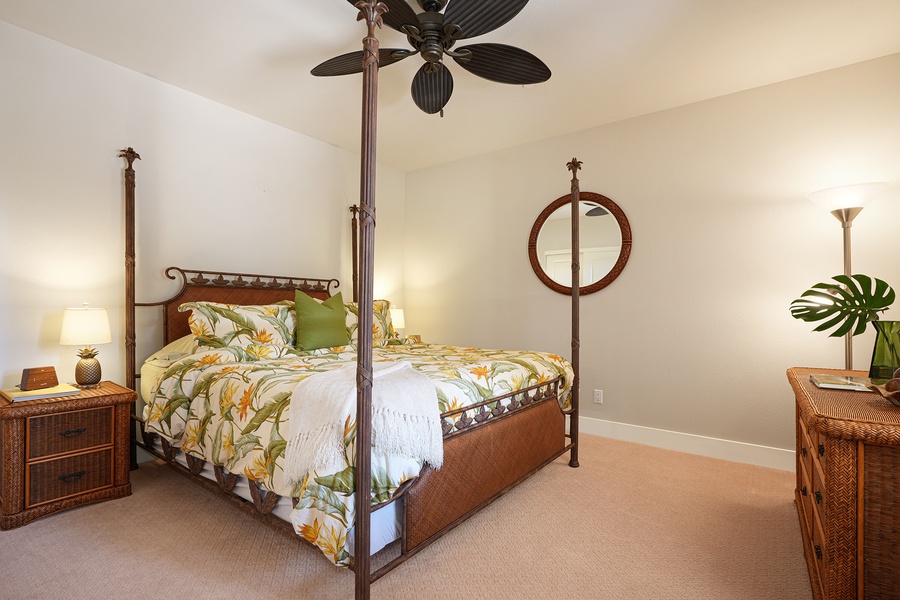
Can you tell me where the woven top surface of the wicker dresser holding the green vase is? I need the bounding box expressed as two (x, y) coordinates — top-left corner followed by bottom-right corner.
(787, 367), (900, 446)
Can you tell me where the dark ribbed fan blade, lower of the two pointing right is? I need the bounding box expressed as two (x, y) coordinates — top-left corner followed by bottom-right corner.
(453, 44), (550, 85)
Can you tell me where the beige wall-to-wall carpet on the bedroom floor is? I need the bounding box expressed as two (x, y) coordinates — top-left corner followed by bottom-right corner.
(0, 436), (811, 600)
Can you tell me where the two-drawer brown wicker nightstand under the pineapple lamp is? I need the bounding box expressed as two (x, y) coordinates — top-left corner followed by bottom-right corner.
(0, 381), (137, 529)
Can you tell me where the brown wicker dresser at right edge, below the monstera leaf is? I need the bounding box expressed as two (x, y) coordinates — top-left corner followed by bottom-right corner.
(787, 367), (900, 600)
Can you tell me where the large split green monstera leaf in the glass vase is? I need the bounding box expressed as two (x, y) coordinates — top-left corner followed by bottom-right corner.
(791, 274), (894, 337)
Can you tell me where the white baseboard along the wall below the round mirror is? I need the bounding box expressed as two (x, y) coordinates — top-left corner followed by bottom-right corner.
(578, 417), (796, 471)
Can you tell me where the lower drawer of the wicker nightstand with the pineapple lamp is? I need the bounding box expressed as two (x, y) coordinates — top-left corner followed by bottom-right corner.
(25, 448), (113, 508)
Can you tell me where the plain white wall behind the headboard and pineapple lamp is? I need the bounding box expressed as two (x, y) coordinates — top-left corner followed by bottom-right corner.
(0, 21), (404, 387)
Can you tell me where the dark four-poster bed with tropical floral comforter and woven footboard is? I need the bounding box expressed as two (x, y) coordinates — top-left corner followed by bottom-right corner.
(120, 0), (580, 599)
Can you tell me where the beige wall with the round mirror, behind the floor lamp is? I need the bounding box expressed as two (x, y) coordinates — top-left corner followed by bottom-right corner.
(405, 55), (900, 449)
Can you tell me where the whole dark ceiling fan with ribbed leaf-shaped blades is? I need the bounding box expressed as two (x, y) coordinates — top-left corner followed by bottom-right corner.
(312, 0), (550, 115)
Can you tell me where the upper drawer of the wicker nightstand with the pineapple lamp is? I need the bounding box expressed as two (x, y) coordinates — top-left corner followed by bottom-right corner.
(26, 406), (113, 460)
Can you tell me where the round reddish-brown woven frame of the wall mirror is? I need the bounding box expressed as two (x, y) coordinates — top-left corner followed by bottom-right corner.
(528, 192), (631, 296)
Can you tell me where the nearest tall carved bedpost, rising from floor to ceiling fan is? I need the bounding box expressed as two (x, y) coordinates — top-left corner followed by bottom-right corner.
(354, 0), (387, 600)
